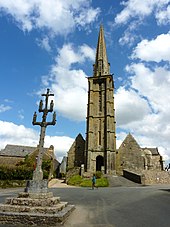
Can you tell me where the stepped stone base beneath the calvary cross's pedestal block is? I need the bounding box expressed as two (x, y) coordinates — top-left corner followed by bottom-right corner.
(0, 192), (75, 226)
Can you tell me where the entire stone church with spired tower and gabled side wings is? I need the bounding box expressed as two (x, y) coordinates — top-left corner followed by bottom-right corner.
(67, 26), (163, 175)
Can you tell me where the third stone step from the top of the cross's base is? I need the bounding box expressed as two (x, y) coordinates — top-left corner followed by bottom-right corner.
(0, 202), (68, 214)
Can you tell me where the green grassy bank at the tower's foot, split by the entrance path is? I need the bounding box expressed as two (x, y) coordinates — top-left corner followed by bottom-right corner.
(68, 175), (109, 187)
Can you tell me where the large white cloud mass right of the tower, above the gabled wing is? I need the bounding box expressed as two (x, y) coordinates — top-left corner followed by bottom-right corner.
(115, 63), (170, 161)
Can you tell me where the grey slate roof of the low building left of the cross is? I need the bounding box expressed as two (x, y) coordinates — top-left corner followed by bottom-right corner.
(0, 144), (47, 157)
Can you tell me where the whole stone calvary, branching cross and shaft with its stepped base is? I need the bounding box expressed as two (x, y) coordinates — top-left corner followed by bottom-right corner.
(0, 89), (75, 226)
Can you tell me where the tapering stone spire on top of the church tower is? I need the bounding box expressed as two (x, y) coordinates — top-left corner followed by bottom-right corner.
(93, 25), (110, 76)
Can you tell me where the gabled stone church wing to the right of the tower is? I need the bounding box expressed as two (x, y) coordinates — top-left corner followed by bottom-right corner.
(116, 134), (163, 175)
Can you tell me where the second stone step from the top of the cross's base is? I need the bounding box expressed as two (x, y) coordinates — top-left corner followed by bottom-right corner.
(6, 197), (60, 207)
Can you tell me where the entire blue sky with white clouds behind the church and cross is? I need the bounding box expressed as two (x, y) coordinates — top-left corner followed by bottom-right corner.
(0, 0), (170, 163)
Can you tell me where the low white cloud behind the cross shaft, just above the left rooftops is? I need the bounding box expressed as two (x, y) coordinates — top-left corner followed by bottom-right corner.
(0, 121), (74, 161)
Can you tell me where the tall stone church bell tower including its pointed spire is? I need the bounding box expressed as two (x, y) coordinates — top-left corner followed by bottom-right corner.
(85, 26), (116, 174)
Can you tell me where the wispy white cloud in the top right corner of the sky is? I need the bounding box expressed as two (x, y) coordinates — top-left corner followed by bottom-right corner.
(114, 0), (170, 46)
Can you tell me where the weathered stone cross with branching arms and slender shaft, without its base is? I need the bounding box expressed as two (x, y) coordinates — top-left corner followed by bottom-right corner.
(32, 89), (56, 181)
